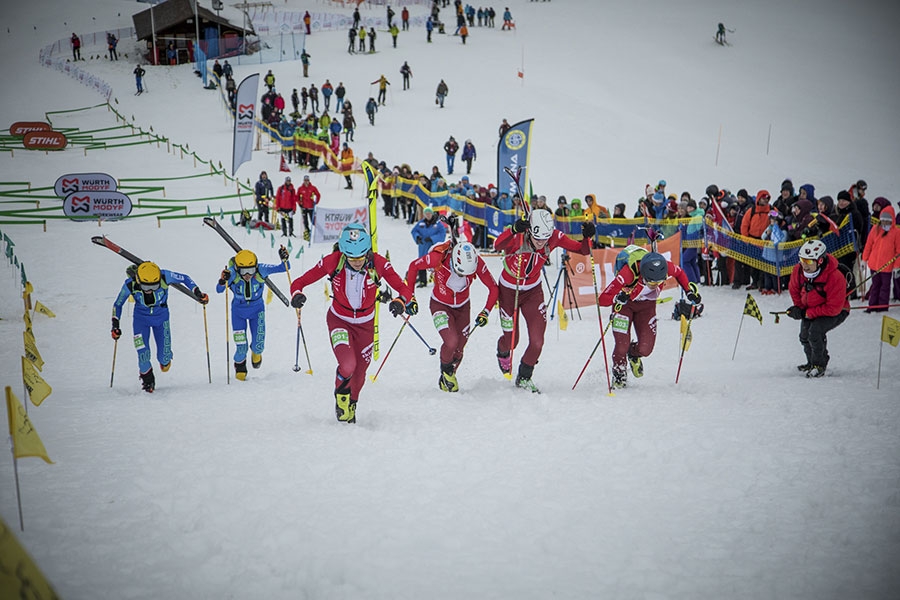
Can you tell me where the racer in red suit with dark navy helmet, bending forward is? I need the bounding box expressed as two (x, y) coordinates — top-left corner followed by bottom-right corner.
(597, 245), (700, 388)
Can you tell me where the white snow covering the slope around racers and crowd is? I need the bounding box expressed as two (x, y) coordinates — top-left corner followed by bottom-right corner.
(0, 0), (900, 600)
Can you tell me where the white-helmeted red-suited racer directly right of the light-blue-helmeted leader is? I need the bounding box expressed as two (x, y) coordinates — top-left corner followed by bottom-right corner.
(406, 241), (498, 392)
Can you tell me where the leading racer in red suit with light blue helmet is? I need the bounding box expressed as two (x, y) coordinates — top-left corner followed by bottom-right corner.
(291, 223), (419, 423)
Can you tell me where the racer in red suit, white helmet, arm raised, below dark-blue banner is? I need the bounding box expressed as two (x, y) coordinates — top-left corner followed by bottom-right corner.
(494, 209), (595, 392)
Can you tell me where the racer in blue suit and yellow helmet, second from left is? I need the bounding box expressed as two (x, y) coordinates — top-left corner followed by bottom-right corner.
(216, 246), (291, 381)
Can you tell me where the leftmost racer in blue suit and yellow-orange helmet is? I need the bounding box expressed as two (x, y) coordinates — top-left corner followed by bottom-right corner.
(111, 261), (209, 393)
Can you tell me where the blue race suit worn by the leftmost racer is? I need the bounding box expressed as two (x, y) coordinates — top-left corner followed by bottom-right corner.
(113, 269), (197, 373)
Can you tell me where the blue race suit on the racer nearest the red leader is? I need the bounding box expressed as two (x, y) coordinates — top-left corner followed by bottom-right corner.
(216, 259), (290, 363)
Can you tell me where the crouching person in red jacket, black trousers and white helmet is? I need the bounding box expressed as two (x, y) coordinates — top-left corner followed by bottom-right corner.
(787, 240), (850, 377)
